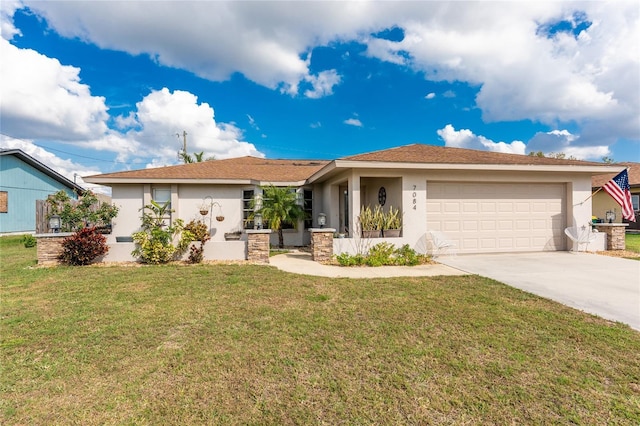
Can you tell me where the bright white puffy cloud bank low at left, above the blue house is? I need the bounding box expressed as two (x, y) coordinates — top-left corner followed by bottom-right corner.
(0, 31), (263, 165)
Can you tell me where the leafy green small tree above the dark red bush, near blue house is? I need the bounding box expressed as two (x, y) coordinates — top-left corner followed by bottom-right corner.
(47, 190), (118, 232)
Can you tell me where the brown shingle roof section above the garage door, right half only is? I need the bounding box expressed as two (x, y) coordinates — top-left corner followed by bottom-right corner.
(340, 144), (603, 166)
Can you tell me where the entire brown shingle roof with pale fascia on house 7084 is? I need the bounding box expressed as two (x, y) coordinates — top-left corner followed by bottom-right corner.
(83, 144), (617, 186)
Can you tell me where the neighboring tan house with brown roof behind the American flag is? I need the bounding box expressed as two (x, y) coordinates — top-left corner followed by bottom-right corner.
(591, 163), (640, 230)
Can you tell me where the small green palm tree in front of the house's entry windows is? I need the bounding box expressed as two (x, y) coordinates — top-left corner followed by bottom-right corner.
(251, 185), (305, 248)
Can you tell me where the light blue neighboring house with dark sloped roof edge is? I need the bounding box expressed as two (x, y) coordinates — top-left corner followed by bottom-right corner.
(0, 149), (84, 234)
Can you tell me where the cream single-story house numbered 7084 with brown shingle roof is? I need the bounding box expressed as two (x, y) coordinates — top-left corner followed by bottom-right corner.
(84, 144), (622, 260)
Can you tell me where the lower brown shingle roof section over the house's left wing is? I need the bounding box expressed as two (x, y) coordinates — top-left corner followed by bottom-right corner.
(89, 157), (328, 182)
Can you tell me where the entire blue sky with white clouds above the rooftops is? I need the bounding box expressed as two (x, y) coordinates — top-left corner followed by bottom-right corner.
(0, 0), (640, 190)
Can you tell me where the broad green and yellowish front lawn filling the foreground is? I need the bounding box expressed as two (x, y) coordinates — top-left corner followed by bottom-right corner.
(0, 237), (640, 425)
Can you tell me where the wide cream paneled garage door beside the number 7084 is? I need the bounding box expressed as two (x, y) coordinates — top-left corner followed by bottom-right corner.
(427, 182), (566, 253)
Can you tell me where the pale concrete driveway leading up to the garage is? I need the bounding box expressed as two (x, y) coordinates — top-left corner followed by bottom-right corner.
(437, 252), (640, 330)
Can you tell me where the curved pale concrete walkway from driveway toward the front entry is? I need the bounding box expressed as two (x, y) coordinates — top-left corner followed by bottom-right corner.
(269, 252), (468, 278)
